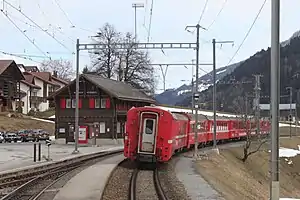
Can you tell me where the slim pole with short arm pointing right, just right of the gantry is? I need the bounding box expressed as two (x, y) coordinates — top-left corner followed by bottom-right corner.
(212, 39), (234, 150)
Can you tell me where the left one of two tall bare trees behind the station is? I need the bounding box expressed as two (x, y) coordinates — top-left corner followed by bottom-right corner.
(90, 23), (121, 78)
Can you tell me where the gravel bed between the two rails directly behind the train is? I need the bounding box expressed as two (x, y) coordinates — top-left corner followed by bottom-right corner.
(136, 170), (159, 200)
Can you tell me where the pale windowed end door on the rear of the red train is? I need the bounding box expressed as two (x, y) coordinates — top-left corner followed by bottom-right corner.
(138, 112), (158, 154)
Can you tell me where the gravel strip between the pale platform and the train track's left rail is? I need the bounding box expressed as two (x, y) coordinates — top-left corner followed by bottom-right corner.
(102, 161), (135, 200)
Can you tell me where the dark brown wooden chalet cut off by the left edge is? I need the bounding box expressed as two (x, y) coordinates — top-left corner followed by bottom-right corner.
(0, 60), (26, 112)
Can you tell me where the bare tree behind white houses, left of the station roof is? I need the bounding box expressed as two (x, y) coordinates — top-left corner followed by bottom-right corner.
(39, 59), (75, 81)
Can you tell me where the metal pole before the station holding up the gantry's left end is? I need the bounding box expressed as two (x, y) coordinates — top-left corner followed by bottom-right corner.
(73, 39), (80, 154)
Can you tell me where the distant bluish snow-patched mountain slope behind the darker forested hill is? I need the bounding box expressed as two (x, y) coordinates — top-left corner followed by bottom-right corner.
(155, 62), (242, 105)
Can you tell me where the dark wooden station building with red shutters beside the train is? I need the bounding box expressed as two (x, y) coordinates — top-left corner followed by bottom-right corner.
(48, 74), (155, 143)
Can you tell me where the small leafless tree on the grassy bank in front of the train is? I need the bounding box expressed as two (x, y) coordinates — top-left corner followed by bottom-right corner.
(233, 94), (268, 162)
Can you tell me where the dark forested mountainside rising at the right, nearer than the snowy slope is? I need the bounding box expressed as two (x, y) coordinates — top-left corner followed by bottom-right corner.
(178, 31), (300, 112)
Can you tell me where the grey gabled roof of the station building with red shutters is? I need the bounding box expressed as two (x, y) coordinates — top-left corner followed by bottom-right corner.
(49, 74), (156, 103)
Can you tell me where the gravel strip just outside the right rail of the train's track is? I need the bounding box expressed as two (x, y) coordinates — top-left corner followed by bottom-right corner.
(159, 158), (191, 200)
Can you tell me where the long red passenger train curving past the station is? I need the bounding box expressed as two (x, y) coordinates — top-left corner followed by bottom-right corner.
(124, 106), (270, 162)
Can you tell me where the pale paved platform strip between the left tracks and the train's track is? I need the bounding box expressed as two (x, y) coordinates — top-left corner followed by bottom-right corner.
(54, 155), (125, 200)
